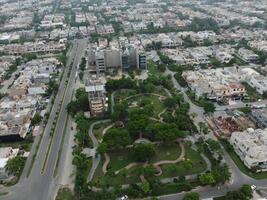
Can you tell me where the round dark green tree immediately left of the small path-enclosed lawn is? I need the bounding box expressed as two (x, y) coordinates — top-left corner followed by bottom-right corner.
(133, 143), (156, 162)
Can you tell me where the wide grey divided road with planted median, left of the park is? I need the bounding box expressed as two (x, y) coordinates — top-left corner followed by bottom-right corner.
(0, 39), (87, 200)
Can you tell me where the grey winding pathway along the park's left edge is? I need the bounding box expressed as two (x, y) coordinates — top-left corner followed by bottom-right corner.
(87, 119), (111, 182)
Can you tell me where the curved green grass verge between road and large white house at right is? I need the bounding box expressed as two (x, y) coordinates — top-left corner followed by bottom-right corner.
(220, 140), (267, 179)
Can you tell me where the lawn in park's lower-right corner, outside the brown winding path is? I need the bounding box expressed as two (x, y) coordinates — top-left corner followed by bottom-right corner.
(160, 147), (207, 178)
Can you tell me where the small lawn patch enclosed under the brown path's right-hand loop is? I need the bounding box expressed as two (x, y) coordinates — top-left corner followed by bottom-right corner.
(151, 144), (181, 163)
